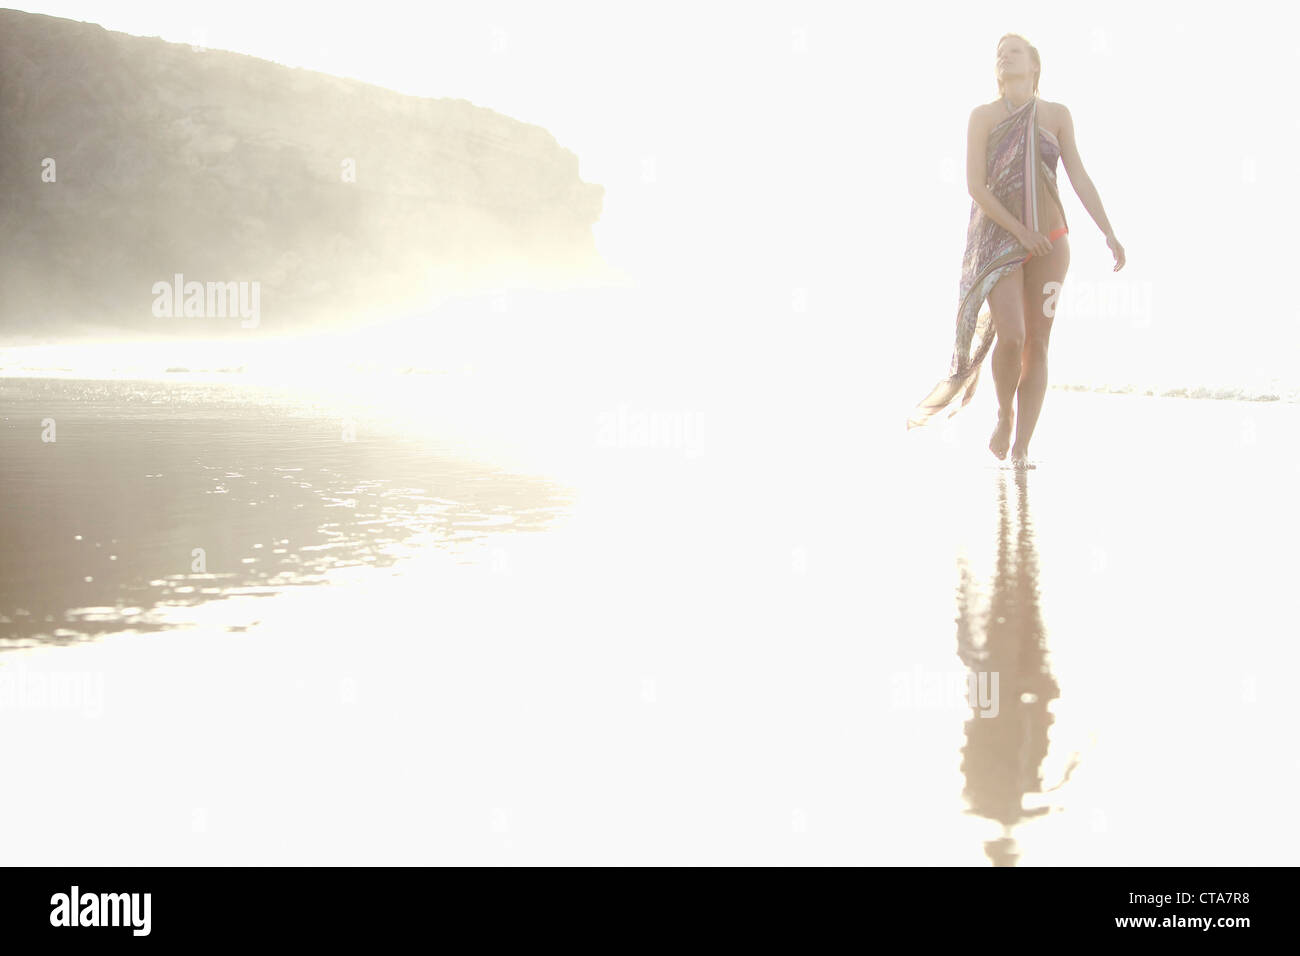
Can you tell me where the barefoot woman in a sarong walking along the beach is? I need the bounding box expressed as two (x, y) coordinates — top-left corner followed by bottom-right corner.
(907, 34), (1125, 468)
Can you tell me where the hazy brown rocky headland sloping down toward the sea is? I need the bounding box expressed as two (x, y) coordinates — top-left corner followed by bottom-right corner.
(0, 10), (605, 338)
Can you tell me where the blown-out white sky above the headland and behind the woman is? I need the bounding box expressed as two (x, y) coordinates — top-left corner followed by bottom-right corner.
(12, 0), (1300, 390)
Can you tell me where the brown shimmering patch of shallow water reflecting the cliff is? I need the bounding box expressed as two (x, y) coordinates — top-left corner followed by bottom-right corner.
(0, 378), (567, 645)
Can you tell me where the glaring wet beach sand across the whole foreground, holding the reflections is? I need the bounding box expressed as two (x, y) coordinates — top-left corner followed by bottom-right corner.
(0, 369), (1300, 865)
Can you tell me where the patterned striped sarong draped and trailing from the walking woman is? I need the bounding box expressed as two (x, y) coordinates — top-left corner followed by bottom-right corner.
(907, 96), (1065, 429)
